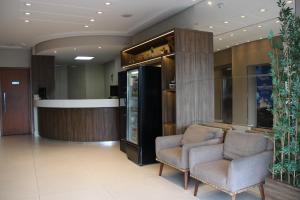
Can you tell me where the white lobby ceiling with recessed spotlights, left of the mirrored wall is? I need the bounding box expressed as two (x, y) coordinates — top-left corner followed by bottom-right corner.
(0, 0), (195, 46)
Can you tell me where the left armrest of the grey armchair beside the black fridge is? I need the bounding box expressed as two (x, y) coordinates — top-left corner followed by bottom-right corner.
(155, 135), (182, 155)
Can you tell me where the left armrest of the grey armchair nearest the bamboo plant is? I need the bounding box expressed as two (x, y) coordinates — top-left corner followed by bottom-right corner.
(189, 144), (224, 169)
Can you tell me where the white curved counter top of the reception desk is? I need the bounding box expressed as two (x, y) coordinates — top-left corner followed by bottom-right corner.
(34, 99), (119, 108)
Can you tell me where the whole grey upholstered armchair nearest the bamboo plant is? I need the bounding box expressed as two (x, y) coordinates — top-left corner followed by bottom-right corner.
(189, 130), (273, 200)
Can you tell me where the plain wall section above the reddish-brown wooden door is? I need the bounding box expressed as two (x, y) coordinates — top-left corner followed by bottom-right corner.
(0, 48), (31, 67)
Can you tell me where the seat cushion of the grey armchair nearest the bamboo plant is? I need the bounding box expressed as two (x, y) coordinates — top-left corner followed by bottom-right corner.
(191, 159), (230, 190)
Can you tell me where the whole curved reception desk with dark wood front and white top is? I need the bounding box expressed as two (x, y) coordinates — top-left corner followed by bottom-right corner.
(34, 99), (119, 142)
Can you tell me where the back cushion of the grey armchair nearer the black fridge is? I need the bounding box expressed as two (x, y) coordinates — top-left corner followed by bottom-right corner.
(181, 124), (223, 145)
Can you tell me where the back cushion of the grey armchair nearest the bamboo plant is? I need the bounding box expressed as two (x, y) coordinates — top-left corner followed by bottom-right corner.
(224, 130), (269, 160)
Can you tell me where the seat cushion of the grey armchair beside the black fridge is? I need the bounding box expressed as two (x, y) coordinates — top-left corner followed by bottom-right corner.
(156, 147), (185, 169)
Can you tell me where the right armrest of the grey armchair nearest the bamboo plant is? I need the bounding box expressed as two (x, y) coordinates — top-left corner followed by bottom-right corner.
(227, 151), (273, 192)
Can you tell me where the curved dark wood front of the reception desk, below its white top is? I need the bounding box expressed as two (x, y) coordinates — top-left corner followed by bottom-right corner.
(38, 108), (119, 142)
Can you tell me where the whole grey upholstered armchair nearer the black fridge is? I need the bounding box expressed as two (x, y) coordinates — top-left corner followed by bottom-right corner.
(156, 124), (223, 189)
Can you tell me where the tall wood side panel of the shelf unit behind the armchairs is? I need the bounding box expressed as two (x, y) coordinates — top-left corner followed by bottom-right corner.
(175, 29), (214, 134)
